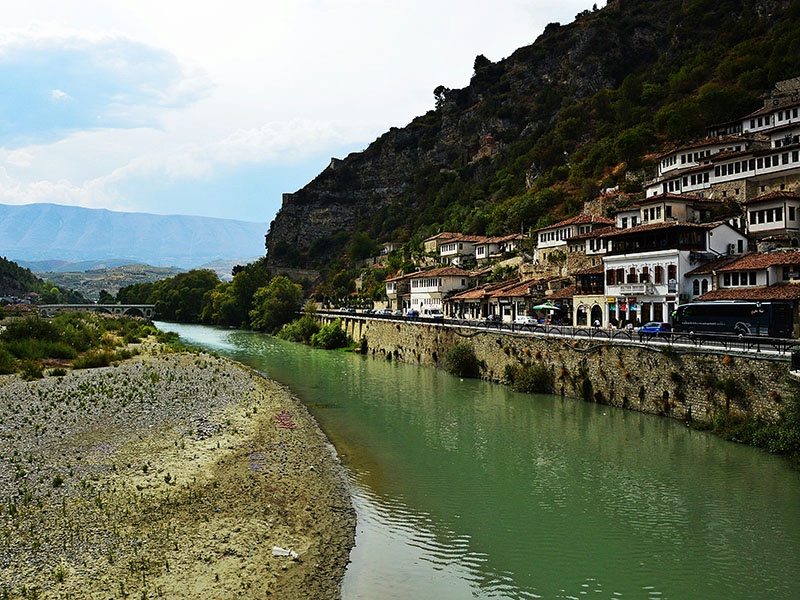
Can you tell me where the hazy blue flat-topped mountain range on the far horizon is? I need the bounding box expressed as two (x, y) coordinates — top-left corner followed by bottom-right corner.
(0, 204), (265, 271)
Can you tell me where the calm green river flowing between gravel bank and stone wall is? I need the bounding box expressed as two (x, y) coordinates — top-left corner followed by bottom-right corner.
(158, 323), (800, 600)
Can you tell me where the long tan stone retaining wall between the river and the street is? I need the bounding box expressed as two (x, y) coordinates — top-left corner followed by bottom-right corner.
(321, 316), (796, 421)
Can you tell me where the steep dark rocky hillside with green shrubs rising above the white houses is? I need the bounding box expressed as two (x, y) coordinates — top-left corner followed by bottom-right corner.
(267, 0), (800, 278)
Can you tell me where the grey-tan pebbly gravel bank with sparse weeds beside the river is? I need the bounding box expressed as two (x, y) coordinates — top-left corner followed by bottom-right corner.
(0, 347), (355, 599)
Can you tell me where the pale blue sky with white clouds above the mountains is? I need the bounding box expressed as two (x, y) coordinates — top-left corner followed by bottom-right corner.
(0, 0), (605, 224)
